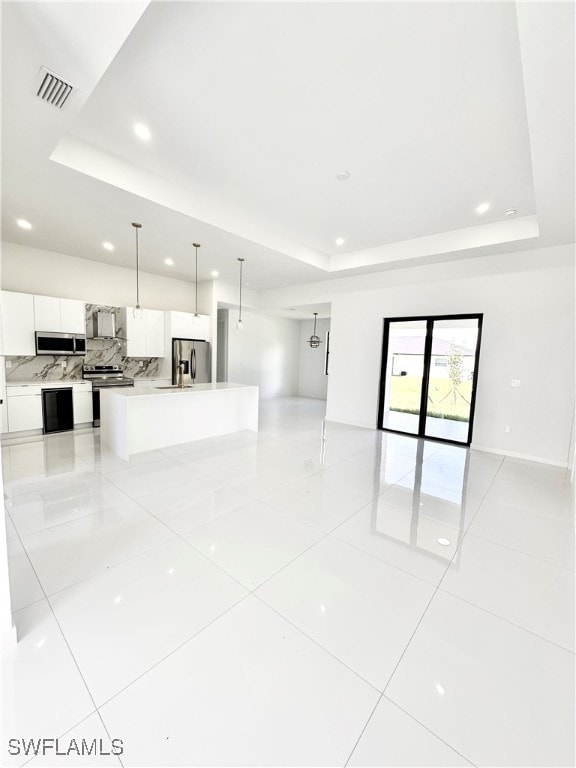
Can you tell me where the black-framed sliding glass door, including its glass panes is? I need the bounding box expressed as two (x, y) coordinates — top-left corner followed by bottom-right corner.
(378, 315), (482, 445)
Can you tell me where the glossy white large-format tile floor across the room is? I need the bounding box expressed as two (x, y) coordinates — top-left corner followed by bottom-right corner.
(0, 398), (575, 767)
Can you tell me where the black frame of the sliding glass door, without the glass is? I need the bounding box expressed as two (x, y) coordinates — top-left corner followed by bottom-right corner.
(376, 312), (484, 446)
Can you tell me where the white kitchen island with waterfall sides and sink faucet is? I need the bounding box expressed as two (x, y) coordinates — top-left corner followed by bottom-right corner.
(100, 382), (258, 460)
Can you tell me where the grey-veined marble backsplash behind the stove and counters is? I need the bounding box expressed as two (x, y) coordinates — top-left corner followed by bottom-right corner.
(6, 304), (163, 382)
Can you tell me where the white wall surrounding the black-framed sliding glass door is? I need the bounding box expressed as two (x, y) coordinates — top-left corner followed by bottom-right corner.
(262, 245), (574, 464)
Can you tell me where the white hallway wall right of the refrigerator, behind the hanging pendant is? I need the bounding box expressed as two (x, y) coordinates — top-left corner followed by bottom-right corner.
(228, 309), (300, 399)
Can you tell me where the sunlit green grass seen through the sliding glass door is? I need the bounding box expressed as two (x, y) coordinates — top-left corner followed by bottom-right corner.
(390, 376), (472, 421)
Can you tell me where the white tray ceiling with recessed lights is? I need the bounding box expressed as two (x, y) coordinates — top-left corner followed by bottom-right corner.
(3, 2), (571, 290)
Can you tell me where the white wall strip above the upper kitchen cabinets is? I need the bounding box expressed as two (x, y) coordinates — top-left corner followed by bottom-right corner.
(1, 242), (213, 314)
